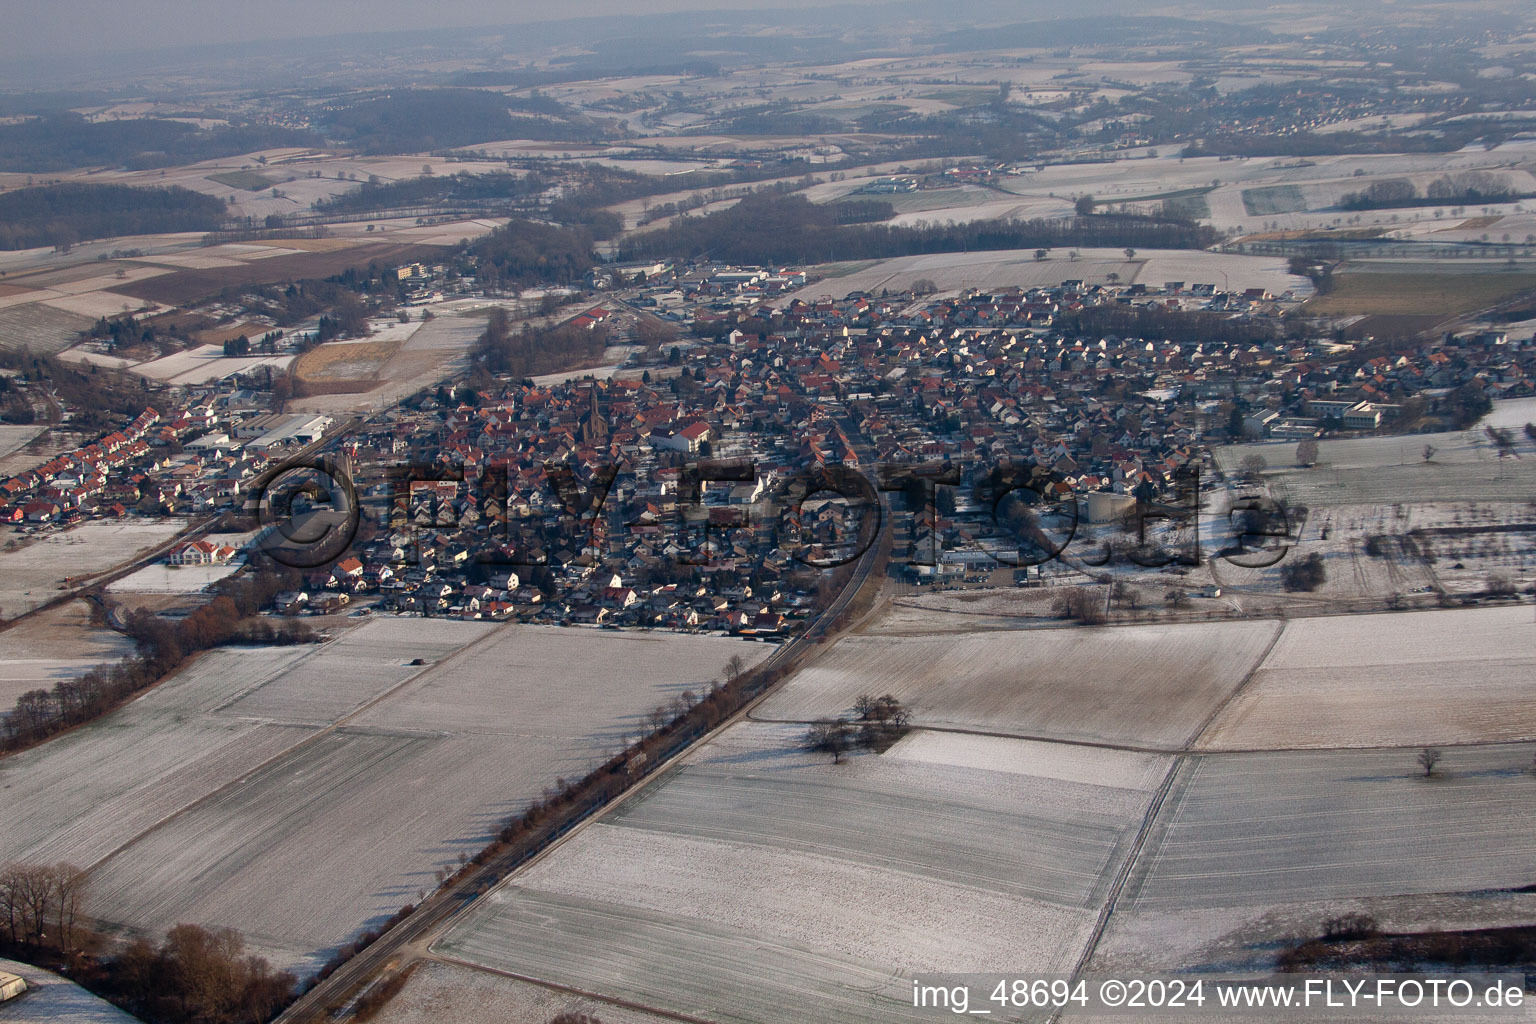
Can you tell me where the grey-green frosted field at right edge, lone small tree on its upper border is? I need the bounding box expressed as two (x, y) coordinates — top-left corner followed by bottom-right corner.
(1120, 745), (1536, 910)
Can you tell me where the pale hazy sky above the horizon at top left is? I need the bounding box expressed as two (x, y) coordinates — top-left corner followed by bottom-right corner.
(0, 0), (841, 58)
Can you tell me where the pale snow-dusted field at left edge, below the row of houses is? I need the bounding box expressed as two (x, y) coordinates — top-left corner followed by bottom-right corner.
(0, 519), (186, 619)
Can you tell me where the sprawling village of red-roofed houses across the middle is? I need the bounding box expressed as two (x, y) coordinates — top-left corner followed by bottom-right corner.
(0, 263), (1536, 639)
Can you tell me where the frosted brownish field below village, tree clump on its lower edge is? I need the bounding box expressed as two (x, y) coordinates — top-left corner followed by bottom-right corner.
(756, 622), (1278, 748)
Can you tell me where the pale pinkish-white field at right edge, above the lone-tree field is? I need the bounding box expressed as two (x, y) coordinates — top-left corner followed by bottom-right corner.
(1198, 606), (1536, 749)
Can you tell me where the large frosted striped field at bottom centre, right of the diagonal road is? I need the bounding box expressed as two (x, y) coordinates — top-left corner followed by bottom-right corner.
(435, 723), (1161, 1022)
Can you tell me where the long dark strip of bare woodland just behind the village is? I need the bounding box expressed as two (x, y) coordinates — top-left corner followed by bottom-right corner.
(622, 193), (1217, 264)
